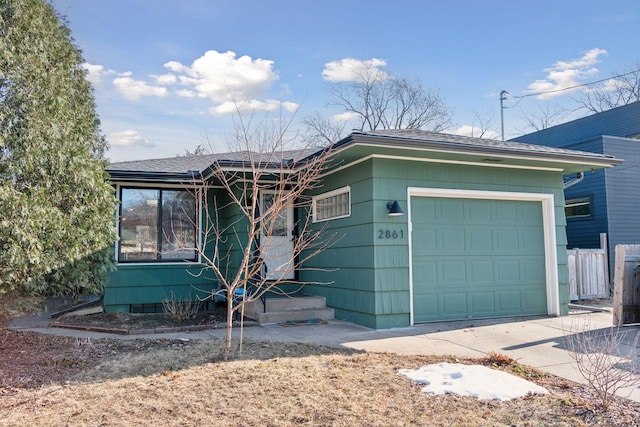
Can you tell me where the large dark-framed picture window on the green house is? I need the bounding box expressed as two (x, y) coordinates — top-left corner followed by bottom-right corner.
(118, 188), (197, 262)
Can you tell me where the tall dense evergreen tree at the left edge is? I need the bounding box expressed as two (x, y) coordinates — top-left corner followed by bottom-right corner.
(0, 0), (116, 296)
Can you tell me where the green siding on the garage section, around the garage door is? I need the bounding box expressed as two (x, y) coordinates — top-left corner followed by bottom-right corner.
(301, 158), (569, 329)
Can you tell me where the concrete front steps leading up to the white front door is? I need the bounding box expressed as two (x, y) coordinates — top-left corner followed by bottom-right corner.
(244, 295), (334, 323)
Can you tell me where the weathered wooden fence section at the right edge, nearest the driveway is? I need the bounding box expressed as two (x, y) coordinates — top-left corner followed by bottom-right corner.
(613, 245), (640, 326)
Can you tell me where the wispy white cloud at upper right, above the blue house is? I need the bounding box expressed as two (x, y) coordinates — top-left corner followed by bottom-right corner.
(526, 48), (607, 99)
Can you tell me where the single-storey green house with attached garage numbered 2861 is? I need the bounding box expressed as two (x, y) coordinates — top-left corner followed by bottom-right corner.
(104, 130), (621, 329)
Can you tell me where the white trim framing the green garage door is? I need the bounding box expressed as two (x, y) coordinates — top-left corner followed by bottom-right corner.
(407, 187), (560, 325)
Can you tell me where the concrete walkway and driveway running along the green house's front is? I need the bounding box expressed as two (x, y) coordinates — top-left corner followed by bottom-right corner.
(10, 306), (640, 402)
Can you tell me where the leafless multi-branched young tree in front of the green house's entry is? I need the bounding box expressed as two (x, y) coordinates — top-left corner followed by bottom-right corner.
(194, 112), (336, 359)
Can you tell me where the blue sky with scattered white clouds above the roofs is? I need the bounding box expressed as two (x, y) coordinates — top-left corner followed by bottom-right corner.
(52, 0), (640, 161)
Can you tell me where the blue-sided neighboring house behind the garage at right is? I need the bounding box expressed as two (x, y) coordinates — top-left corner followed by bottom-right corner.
(513, 102), (640, 276)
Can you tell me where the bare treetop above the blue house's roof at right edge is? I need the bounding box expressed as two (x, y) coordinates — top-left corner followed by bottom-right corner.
(575, 62), (640, 113)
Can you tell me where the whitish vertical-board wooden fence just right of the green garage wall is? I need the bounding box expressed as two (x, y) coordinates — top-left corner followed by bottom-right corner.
(567, 235), (609, 301)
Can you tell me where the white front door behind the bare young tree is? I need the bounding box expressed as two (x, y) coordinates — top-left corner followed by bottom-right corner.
(260, 191), (295, 280)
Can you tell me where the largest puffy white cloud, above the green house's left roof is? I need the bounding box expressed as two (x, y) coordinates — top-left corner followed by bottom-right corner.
(164, 50), (278, 104)
